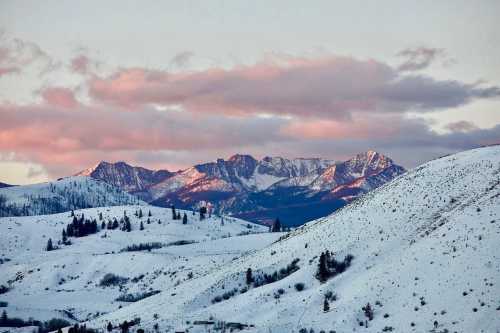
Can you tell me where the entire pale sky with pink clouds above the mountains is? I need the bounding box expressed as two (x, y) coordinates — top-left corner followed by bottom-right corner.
(0, 0), (500, 184)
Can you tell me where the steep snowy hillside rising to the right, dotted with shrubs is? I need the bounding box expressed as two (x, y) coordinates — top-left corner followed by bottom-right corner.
(81, 146), (500, 333)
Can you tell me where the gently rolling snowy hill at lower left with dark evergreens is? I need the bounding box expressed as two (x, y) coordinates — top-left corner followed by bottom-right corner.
(0, 206), (274, 320)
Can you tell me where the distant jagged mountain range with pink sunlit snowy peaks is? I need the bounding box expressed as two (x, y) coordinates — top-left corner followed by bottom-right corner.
(77, 150), (405, 226)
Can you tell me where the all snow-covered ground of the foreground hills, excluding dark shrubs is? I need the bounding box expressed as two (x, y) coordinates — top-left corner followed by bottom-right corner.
(0, 146), (500, 333)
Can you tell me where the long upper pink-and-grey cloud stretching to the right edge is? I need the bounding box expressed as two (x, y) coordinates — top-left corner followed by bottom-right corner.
(89, 57), (500, 120)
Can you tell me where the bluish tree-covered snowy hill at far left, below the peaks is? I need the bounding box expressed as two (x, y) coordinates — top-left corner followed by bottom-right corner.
(0, 176), (145, 216)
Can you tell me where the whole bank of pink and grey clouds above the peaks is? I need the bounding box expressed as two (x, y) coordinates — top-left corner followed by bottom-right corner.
(0, 37), (500, 177)
